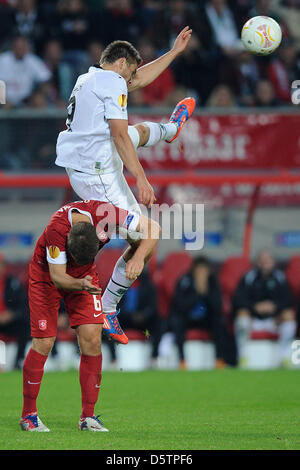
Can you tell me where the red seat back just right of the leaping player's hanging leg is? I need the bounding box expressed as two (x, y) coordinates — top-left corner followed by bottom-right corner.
(157, 251), (192, 316)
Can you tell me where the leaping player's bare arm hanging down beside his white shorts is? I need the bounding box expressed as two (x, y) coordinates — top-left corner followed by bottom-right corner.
(109, 119), (156, 207)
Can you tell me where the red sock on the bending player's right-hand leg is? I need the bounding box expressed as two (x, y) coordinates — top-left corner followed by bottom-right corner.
(79, 354), (102, 418)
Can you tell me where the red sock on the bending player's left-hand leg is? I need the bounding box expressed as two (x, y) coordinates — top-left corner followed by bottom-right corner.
(22, 349), (48, 417)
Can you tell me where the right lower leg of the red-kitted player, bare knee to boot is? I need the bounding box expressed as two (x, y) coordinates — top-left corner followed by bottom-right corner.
(76, 324), (108, 432)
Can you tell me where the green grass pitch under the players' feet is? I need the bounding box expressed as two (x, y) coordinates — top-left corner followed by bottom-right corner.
(0, 369), (300, 450)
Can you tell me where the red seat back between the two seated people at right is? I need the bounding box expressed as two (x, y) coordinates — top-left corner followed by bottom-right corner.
(219, 256), (251, 315)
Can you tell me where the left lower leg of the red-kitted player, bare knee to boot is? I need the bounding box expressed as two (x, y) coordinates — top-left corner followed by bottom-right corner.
(20, 337), (55, 432)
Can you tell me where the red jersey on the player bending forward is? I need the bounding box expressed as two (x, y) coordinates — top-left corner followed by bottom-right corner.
(30, 200), (139, 281)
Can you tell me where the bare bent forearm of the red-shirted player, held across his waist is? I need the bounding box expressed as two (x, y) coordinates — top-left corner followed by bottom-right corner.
(48, 263), (101, 295)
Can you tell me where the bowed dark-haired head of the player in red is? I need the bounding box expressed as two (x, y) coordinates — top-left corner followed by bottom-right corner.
(68, 222), (99, 265)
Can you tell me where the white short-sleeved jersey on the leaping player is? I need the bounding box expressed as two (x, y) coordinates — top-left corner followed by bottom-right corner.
(55, 66), (128, 174)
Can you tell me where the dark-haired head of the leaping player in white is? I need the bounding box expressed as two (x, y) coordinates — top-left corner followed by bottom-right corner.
(100, 41), (142, 82)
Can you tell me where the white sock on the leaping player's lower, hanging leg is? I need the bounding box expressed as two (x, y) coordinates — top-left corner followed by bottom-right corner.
(102, 256), (134, 313)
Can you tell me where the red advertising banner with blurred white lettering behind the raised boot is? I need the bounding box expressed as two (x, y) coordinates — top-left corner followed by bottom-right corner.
(130, 113), (300, 170)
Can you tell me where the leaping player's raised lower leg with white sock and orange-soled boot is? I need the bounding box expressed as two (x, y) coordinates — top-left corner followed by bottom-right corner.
(128, 97), (196, 149)
